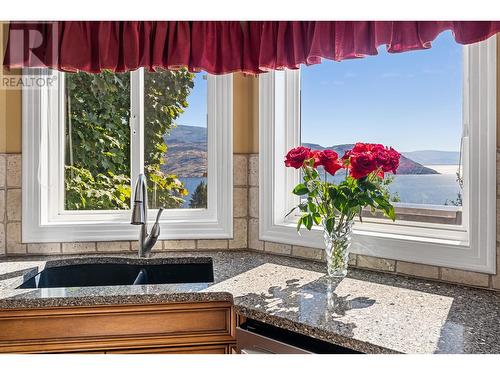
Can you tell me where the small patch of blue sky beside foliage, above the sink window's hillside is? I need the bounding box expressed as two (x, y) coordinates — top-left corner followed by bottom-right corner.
(175, 72), (207, 128)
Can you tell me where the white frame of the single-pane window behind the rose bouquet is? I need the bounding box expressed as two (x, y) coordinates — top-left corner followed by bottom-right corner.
(259, 37), (497, 273)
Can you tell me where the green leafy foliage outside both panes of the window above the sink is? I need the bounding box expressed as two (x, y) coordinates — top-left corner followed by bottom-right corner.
(65, 70), (194, 210)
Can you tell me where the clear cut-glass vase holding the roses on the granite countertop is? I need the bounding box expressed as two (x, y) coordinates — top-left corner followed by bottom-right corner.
(323, 220), (353, 277)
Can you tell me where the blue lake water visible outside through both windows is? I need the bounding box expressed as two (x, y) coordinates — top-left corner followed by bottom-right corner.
(180, 165), (460, 207)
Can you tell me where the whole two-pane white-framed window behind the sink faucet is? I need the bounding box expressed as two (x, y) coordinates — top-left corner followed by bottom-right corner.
(23, 69), (232, 242)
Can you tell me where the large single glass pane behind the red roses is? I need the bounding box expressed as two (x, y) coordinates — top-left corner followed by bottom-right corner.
(301, 33), (463, 223)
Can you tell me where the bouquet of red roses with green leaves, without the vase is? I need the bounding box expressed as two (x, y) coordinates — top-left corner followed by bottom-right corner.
(285, 143), (401, 235)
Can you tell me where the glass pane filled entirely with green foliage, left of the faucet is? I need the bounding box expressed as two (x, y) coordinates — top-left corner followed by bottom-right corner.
(64, 72), (130, 210)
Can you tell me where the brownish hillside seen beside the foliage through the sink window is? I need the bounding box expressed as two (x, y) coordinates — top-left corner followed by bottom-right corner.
(161, 125), (207, 178)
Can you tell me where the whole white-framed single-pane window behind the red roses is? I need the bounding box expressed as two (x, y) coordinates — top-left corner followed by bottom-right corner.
(260, 34), (496, 272)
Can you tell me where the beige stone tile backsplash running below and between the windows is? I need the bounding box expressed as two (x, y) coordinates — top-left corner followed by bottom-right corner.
(0, 153), (500, 290)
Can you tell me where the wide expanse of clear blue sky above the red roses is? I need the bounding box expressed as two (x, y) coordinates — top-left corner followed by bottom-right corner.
(301, 32), (463, 151)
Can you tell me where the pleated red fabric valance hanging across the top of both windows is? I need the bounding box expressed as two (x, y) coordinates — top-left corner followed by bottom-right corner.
(4, 21), (500, 74)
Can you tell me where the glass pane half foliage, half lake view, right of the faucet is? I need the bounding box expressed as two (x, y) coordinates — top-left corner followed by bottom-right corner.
(144, 69), (207, 208)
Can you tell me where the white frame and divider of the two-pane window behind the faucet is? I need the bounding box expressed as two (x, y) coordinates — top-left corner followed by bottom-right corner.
(22, 69), (233, 243)
